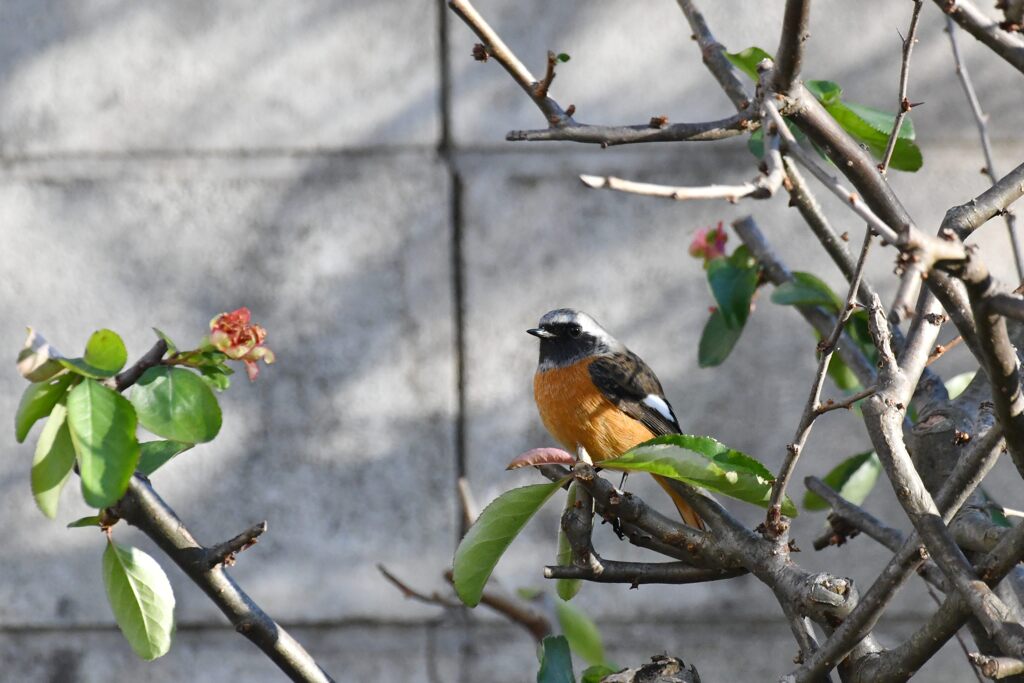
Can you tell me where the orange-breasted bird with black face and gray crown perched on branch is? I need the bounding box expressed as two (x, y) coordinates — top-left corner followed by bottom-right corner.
(526, 308), (705, 529)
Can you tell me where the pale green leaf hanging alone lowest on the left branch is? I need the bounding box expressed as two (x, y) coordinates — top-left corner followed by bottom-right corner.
(103, 541), (174, 659)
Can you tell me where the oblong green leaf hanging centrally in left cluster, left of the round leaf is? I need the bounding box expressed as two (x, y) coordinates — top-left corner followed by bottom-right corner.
(68, 380), (139, 508)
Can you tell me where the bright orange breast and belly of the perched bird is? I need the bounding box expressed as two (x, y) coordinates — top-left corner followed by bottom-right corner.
(534, 358), (654, 461)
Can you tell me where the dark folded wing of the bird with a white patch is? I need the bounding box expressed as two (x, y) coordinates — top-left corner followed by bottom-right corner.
(589, 351), (682, 436)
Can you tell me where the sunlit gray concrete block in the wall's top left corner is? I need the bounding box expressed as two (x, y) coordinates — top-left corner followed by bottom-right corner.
(0, 0), (440, 156)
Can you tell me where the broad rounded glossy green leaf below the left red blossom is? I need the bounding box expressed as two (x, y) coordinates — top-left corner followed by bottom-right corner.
(131, 366), (221, 443)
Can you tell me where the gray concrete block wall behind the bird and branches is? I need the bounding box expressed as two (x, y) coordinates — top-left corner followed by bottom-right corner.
(0, 0), (1024, 683)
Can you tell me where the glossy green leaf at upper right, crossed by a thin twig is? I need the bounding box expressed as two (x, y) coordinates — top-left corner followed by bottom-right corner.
(804, 81), (924, 171)
